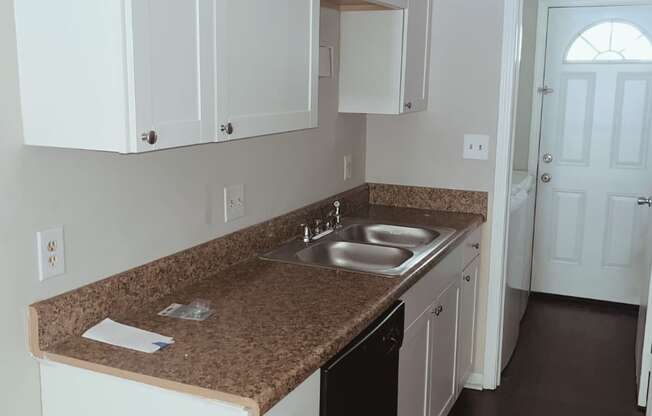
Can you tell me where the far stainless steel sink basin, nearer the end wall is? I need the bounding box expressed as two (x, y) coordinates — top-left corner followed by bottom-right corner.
(339, 224), (440, 248)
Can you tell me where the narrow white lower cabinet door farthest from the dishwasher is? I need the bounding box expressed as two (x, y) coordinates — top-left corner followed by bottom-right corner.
(457, 256), (480, 394)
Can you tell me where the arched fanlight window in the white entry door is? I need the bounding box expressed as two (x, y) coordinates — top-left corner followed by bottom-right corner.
(565, 20), (652, 63)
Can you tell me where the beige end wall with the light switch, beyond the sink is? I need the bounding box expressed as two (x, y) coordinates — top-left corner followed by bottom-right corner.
(367, 0), (503, 372)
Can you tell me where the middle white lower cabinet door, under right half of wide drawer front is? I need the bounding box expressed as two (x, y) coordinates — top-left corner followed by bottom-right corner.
(430, 280), (459, 416)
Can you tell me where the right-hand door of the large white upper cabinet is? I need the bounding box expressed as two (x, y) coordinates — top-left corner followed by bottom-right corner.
(214, 0), (320, 140)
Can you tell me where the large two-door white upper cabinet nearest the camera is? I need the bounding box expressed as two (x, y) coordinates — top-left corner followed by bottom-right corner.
(15, 0), (319, 153)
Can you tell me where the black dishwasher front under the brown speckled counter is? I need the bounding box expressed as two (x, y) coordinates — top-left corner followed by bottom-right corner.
(320, 302), (405, 416)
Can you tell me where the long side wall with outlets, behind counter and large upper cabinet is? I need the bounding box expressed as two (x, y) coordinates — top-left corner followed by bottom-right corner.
(0, 6), (366, 416)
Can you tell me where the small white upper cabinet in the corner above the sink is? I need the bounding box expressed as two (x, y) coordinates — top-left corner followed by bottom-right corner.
(339, 0), (432, 114)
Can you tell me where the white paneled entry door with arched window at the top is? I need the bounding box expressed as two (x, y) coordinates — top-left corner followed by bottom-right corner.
(533, 6), (652, 304)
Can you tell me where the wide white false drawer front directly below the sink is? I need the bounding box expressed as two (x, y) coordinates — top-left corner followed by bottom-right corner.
(401, 247), (463, 328)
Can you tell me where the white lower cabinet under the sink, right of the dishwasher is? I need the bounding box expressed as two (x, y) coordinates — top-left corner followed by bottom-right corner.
(398, 228), (480, 416)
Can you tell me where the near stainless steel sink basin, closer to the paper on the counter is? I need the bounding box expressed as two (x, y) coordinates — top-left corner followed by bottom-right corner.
(297, 241), (413, 273)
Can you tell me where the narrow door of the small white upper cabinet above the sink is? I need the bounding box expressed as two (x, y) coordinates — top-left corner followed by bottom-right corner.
(401, 0), (432, 113)
